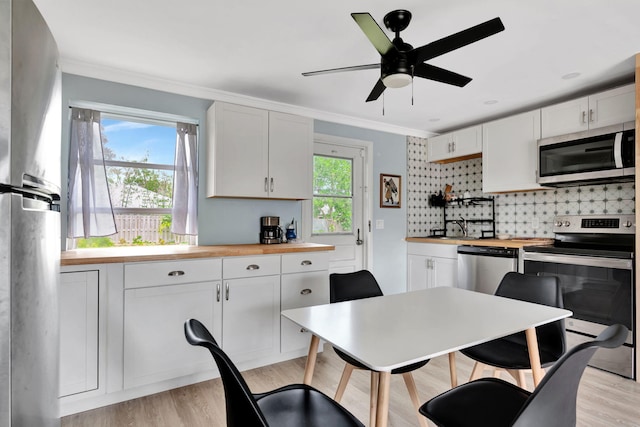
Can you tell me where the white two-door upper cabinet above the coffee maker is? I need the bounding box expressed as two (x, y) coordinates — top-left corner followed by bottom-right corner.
(207, 102), (313, 200)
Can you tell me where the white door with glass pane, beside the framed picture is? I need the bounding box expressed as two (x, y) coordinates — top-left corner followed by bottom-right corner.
(305, 142), (370, 273)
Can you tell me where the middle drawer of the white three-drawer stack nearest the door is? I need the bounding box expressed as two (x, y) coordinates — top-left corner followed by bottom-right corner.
(280, 270), (329, 310)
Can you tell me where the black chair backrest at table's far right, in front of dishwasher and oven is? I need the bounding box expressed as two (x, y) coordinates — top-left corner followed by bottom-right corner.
(496, 272), (566, 359)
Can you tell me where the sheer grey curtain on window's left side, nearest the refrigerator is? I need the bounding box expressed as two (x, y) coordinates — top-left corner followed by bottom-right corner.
(67, 108), (117, 238)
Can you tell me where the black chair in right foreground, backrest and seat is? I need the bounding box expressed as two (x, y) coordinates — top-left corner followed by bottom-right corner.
(420, 325), (629, 427)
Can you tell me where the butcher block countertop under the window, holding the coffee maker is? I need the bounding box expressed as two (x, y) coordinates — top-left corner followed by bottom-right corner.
(60, 243), (335, 266)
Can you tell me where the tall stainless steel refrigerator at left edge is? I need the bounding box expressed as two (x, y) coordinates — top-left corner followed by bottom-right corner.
(0, 0), (62, 427)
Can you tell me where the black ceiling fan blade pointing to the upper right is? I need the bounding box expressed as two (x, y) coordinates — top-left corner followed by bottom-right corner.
(413, 18), (504, 62)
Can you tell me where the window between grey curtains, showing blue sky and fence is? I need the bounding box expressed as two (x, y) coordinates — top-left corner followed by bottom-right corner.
(75, 113), (197, 248)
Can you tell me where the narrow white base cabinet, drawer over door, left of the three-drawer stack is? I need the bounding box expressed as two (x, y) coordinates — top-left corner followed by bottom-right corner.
(222, 255), (280, 363)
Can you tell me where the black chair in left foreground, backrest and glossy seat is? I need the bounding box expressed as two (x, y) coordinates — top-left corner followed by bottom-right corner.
(184, 319), (364, 427)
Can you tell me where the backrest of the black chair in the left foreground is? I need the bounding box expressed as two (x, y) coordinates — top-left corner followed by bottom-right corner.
(184, 319), (268, 427)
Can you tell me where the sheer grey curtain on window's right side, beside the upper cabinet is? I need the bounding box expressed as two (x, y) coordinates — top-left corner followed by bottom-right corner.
(171, 123), (198, 235)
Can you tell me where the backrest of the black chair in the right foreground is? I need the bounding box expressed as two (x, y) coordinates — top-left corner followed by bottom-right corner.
(512, 325), (629, 427)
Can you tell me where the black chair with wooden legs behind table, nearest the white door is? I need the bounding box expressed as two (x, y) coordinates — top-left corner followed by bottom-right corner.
(329, 270), (429, 427)
